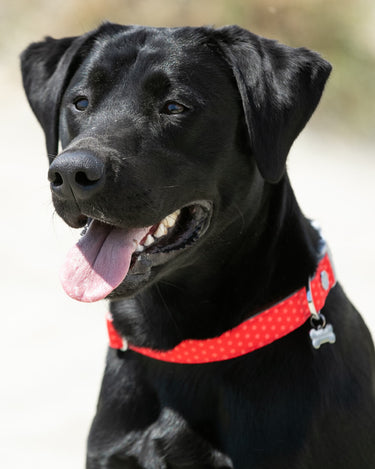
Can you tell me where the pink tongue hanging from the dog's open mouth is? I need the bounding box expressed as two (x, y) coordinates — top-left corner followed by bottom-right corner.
(60, 221), (150, 302)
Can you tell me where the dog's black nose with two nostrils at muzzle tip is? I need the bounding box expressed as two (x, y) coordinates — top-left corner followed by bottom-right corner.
(48, 151), (104, 200)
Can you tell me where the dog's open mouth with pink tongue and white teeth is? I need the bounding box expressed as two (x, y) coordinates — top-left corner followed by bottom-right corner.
(61, 201), (212, 302)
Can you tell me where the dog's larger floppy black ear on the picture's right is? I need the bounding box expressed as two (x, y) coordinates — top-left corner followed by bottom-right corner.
(216, 26), (331, 182)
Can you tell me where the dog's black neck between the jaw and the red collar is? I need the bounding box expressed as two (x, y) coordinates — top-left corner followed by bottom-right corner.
(111, 176), (319, 349)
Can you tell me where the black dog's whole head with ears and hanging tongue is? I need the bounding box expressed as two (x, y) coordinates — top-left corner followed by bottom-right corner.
(22, 23), (330, 301)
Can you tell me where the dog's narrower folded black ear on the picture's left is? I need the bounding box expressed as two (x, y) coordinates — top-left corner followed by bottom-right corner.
(21, 31), (96, 161)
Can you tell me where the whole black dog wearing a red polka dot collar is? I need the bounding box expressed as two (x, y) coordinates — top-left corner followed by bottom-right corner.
(22, 24), (375, 469)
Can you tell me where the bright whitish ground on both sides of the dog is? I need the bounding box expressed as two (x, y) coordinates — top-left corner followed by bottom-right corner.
(0, 75), (375, 469)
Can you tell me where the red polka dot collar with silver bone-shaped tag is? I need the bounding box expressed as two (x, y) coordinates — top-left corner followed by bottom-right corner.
(107, 249), (336, 364)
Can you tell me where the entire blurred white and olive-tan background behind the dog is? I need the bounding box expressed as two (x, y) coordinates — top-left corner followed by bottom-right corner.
(0, 0), (375, 469)
